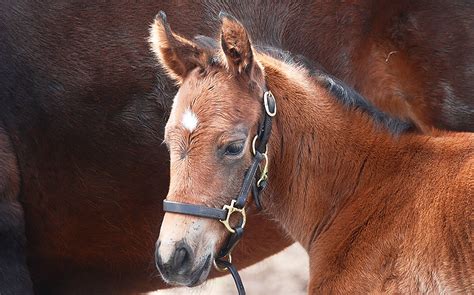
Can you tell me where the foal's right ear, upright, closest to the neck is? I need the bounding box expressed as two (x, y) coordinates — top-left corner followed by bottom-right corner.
(219, 12), (258, 74)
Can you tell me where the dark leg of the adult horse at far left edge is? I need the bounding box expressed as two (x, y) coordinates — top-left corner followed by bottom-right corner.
(0, 126), (33, 295)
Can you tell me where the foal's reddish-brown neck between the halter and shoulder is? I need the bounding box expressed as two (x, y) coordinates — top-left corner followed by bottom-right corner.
(263, 57), (412, 249)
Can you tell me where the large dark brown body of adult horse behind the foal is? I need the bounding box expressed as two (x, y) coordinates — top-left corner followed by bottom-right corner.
(0, 0), (474, 294)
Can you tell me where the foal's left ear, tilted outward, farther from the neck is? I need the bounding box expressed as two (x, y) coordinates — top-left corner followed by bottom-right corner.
(149, 11), (206, 83)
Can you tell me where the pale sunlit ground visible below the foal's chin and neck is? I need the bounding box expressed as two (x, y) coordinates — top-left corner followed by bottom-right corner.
(149, 244), (308, 295)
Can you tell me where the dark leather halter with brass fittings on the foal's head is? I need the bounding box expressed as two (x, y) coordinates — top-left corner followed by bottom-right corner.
(163, 90), (276, 295)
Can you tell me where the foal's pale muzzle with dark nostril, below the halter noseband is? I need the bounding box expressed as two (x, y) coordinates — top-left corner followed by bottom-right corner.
(155, 213), (219, 287)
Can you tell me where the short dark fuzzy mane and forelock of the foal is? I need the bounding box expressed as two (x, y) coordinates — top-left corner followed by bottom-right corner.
(194, 35), (415, 135)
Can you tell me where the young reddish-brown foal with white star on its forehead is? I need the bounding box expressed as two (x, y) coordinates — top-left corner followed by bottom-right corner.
(150, 14), (474, 294)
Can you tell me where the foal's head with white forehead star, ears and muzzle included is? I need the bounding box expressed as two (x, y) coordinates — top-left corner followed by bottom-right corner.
(150, 13), (265, 286)
